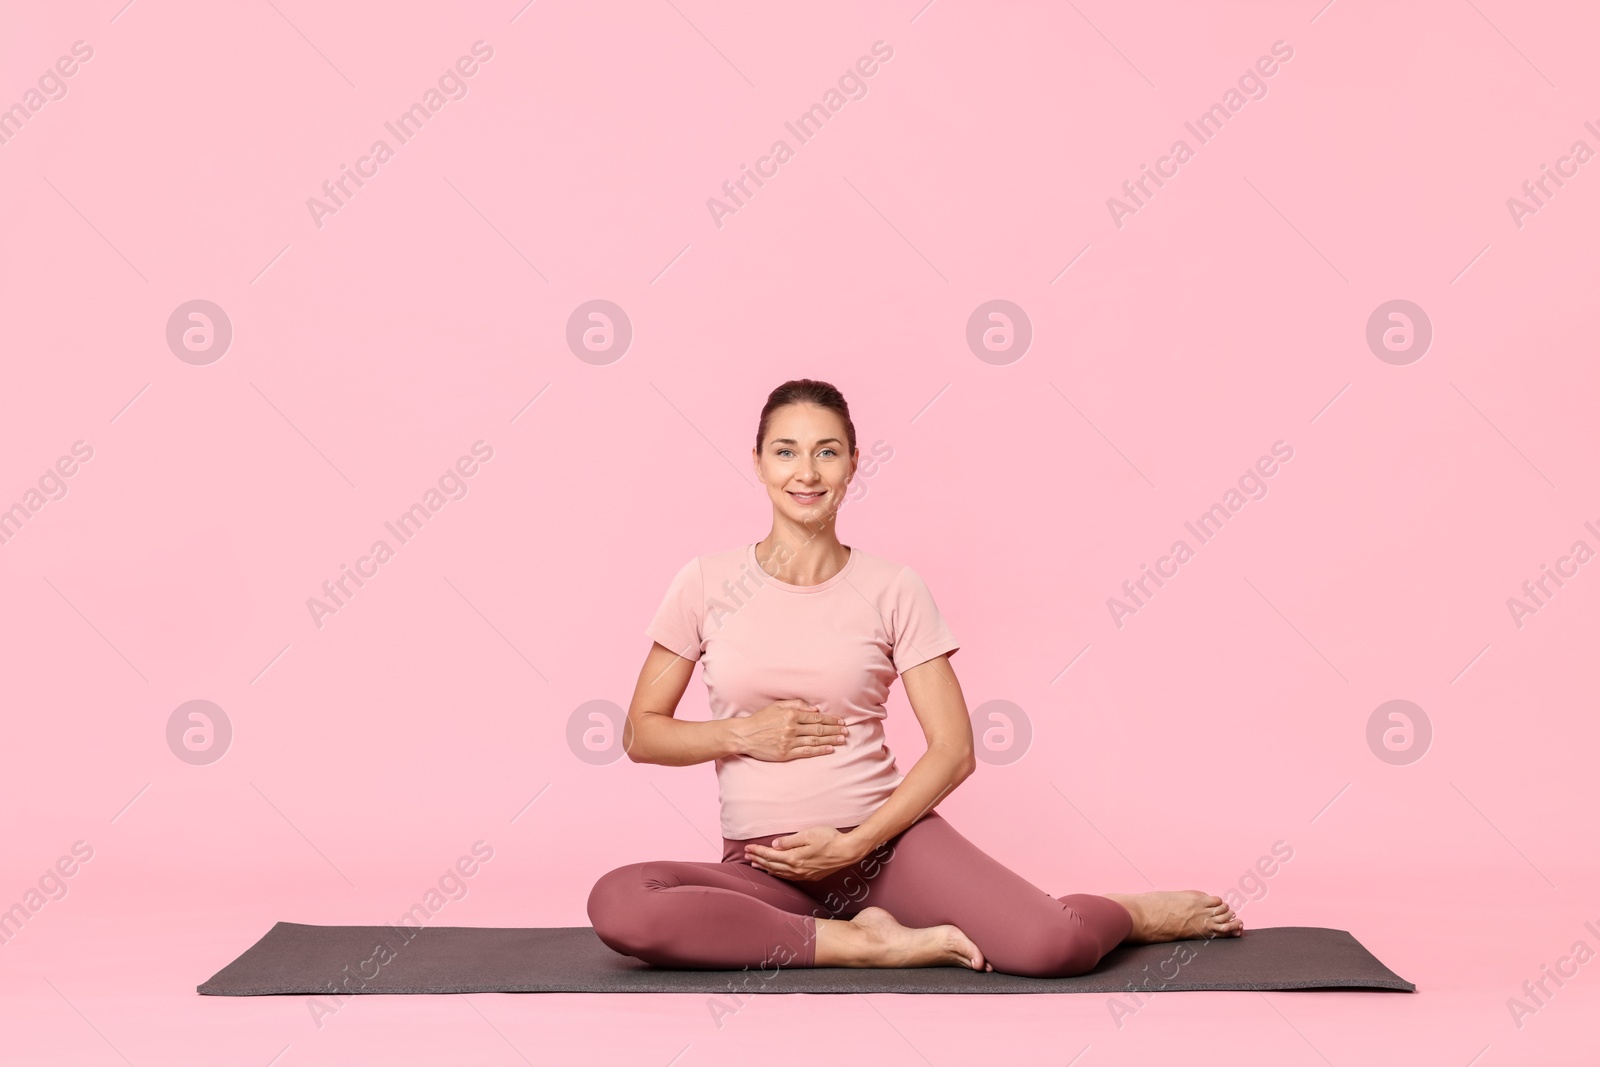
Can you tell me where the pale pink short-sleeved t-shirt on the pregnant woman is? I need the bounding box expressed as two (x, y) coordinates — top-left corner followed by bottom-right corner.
(645, 544), (958, 840)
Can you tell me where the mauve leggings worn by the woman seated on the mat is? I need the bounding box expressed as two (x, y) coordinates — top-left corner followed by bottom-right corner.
(589, 811), (1133, 977)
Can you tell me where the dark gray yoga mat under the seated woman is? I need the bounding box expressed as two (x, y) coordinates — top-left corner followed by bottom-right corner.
(198, 923), (1416, 997)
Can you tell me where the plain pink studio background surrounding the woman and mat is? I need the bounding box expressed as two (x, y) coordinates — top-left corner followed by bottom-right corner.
(0, 0), (1600, 1067)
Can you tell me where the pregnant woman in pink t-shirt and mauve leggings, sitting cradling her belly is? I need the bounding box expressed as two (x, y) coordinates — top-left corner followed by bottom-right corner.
(589, 379), (1243, 977)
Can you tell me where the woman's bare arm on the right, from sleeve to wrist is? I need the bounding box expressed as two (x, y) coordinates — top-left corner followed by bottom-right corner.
(845, 656), (978, 859)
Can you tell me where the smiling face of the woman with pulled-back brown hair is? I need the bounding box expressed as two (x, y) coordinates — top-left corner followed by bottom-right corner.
(750, 403), (859, 530)
